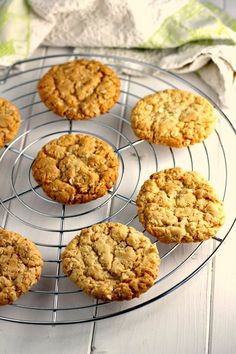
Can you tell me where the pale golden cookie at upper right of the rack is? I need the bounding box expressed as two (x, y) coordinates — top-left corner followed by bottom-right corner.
(131, 89), (216, 148)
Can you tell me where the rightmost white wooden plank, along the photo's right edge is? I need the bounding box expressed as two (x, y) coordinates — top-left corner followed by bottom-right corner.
(206, 103), (236, 354)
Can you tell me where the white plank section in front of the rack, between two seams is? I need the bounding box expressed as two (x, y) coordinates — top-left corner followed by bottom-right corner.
(91, 268), (209, 354)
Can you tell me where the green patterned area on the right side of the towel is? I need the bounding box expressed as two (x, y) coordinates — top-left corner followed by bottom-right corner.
(145, 0), (236, 48)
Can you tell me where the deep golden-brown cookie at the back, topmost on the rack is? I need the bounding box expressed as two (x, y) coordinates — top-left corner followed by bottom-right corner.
(38, 59), (120, 120)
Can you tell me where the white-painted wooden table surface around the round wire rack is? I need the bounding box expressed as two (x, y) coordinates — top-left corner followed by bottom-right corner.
(0, 0), (236, 354)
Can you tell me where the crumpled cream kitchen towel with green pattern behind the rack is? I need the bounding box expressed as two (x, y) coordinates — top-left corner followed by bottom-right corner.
(0, 0), (236, 105)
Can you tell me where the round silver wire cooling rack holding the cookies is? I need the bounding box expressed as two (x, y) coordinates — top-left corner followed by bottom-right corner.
(0, 54), (236, 325)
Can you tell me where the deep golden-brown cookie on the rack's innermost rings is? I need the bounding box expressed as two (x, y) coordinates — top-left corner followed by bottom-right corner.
(32, 134), (119, 204)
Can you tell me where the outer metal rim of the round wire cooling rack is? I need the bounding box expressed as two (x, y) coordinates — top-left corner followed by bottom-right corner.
(0, 53), (236, 326)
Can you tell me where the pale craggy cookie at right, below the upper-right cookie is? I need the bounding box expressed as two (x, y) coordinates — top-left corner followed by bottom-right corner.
(136, 167), (224, 243)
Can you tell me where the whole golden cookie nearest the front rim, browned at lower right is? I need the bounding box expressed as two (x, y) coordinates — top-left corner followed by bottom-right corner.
(62, 223), (160, 301)
